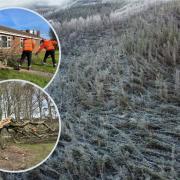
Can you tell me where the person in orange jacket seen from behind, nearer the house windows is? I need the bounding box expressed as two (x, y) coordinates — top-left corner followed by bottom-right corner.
(19, 38), (35, 70)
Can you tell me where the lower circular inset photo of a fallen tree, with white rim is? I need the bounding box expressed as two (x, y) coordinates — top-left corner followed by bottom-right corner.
(0, 80), (61, 172)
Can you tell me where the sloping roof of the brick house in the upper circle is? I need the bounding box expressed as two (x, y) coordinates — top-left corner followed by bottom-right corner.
(0, 25), (41, 38)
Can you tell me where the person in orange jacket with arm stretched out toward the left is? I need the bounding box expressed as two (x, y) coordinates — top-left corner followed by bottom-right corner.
(36, 39), (57, 67)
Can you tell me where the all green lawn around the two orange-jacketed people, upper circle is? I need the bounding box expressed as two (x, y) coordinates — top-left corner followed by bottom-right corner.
(0, 51), (59, 87)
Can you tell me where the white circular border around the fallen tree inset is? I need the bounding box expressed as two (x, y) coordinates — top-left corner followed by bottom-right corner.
(0, 79), (61, 173)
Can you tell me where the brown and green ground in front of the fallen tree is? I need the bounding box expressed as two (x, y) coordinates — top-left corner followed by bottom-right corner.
(0, 143), (54, 171)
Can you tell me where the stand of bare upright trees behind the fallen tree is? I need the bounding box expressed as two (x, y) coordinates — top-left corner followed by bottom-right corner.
(0, 82), (56, 121)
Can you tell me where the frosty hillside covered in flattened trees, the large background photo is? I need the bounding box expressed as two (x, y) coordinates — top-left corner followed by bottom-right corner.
(0, 0), (180, 180)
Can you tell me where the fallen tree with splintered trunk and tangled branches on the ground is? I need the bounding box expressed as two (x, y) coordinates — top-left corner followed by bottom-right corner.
(0, 118), (56, 149)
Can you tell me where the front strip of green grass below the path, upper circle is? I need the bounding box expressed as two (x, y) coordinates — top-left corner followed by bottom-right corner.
(0, 69), (51, 87)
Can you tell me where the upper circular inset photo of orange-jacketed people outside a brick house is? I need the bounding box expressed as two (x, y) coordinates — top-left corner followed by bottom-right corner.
(0, 8), (61, 88)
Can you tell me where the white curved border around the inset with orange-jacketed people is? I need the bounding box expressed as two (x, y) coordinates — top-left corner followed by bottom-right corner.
(0, 6), (61, 89)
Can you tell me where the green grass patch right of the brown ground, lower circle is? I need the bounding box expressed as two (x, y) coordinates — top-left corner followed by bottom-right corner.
(16, 143), (55, 167)
